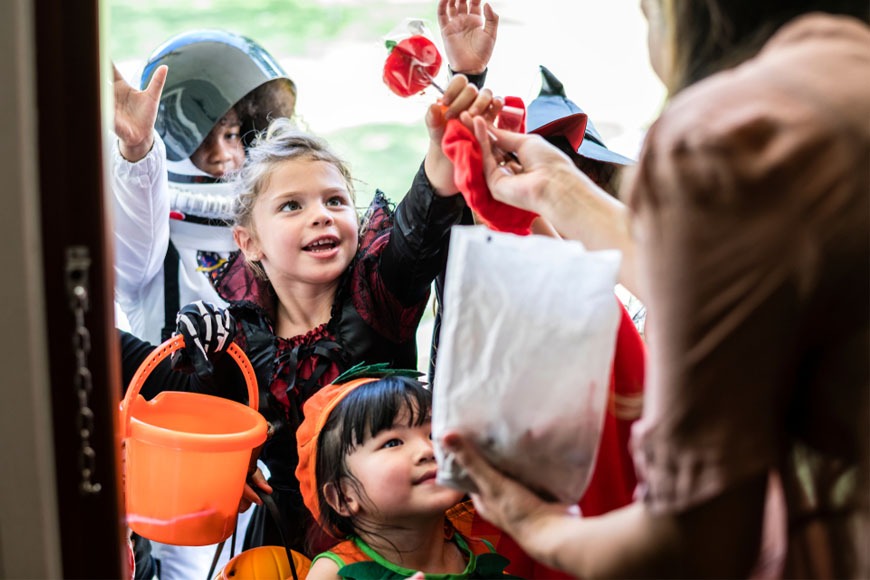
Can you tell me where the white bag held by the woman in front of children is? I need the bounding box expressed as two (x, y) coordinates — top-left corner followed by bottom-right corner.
(432, 226), (621, 503)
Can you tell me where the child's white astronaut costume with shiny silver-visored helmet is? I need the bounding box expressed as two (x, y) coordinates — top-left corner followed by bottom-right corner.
(112, 30), (295, 580)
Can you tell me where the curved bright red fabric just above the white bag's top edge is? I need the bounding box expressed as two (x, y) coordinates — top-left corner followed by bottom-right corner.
(441, 119), (538, 236)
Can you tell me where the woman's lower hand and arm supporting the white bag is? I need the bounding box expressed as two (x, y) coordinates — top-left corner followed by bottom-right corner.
(443, 432), (767, 578)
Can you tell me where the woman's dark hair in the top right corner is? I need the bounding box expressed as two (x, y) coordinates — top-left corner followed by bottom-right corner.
(659, 0), (870, 95)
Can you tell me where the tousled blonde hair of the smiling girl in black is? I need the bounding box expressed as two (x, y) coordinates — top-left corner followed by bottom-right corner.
(232, 117), (356, 279)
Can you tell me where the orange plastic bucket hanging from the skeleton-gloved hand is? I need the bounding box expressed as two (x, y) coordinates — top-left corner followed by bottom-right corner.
(120, 336), (266, 546)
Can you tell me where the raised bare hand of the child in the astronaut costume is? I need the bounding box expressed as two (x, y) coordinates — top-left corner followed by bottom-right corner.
(112, 64), (169, 162)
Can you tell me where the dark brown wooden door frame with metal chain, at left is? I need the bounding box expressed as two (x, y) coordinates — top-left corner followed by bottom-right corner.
(33, 0), (127, 578)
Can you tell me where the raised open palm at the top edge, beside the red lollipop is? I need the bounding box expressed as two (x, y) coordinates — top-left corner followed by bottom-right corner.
(438, 0), (498, 74)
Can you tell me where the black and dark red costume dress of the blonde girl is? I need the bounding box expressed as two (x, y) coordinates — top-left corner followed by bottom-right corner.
(122, 166), (465, 553)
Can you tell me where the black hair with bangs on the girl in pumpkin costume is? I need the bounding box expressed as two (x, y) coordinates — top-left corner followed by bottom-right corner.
(315, 376), (432, 537)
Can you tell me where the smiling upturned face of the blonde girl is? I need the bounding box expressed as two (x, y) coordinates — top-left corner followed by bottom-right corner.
(236, 158), (359, 288)
